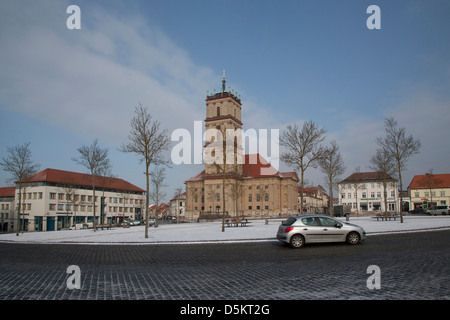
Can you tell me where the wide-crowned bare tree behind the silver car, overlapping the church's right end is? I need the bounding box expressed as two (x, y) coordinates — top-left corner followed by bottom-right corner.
(280, 121), (326, 212)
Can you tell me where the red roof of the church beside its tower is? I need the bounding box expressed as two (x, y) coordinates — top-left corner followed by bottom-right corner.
(187, 154), (298, 182)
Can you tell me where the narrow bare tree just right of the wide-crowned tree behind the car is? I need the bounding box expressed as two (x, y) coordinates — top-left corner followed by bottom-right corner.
(319, 140), (345, 215)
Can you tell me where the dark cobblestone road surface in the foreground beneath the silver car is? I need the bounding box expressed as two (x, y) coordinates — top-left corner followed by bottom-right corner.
(0, 231), (450, 300)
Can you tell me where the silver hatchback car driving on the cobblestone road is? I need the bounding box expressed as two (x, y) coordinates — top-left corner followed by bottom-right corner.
(277, 214), (366, 248)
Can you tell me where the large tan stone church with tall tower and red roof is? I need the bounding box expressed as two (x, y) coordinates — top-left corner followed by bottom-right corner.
(185, 74), (299, 221)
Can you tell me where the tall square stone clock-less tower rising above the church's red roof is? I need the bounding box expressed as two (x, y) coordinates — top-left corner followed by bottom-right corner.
(205, 71), (243, 175)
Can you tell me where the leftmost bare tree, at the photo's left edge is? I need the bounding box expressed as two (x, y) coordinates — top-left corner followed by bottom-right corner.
(0, 142), (39, 236)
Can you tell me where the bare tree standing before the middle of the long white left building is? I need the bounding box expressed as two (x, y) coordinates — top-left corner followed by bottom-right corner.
(72, 138), (110, 232)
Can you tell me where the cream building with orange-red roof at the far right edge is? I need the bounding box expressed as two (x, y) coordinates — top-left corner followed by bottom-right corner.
(408, 173), (450, 210)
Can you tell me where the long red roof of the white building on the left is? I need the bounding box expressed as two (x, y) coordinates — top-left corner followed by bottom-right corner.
(22, 169), (145, 192)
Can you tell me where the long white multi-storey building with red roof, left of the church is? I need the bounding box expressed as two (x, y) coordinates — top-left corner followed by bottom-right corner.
(11, 169), (145, 231)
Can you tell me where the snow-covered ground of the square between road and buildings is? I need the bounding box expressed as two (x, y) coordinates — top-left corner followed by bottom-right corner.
(0, 216), (450, 244)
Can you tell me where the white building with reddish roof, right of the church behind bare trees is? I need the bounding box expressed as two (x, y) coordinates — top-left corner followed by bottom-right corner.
(338, 172), (399, 213)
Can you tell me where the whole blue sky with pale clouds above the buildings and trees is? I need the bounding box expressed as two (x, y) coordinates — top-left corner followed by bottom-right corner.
(0, 0), (450, 200)
